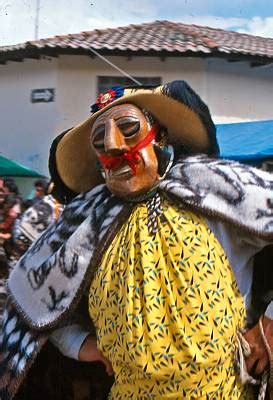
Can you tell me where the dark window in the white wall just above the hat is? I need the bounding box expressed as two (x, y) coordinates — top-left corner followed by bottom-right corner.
(98, 76), (161, 93)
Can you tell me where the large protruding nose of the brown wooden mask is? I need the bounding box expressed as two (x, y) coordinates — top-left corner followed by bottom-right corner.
(104, 119), (129, 155)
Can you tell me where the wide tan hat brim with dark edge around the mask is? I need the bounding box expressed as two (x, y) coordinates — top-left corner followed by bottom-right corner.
(51, 81), (218, 193)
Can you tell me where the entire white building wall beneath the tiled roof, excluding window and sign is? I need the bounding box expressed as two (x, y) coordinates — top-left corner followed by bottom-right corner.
(0, 56), (273, 174)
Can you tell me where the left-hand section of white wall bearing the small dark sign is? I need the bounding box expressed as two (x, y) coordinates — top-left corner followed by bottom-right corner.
(0, 59), (57, 173)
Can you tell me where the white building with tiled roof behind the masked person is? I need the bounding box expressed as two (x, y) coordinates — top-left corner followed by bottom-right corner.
(0, 21), (273, 174)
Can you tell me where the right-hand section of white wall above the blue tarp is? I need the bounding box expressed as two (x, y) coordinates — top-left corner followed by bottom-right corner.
(205, 59), (273, 123)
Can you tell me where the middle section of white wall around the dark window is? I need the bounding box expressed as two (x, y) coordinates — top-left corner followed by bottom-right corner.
(57, 56), (204, 132)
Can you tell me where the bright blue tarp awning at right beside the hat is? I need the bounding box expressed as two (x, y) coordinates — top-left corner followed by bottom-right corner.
(217, 120), (273, 163)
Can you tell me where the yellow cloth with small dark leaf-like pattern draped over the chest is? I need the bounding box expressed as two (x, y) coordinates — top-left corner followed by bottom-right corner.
(89, 200), (248, 400)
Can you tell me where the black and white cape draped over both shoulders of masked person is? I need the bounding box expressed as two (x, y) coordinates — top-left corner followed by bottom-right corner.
(0, 156), (273, 400)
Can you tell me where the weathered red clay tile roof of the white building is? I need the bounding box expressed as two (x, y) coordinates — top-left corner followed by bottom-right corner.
(0, 21), (273, 62)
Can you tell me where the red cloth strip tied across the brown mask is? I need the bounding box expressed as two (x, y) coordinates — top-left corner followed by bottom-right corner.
(99, 124), (159, 175)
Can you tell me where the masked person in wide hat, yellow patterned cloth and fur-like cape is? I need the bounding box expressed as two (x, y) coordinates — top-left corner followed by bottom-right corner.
(0, 81), (273, 400)
